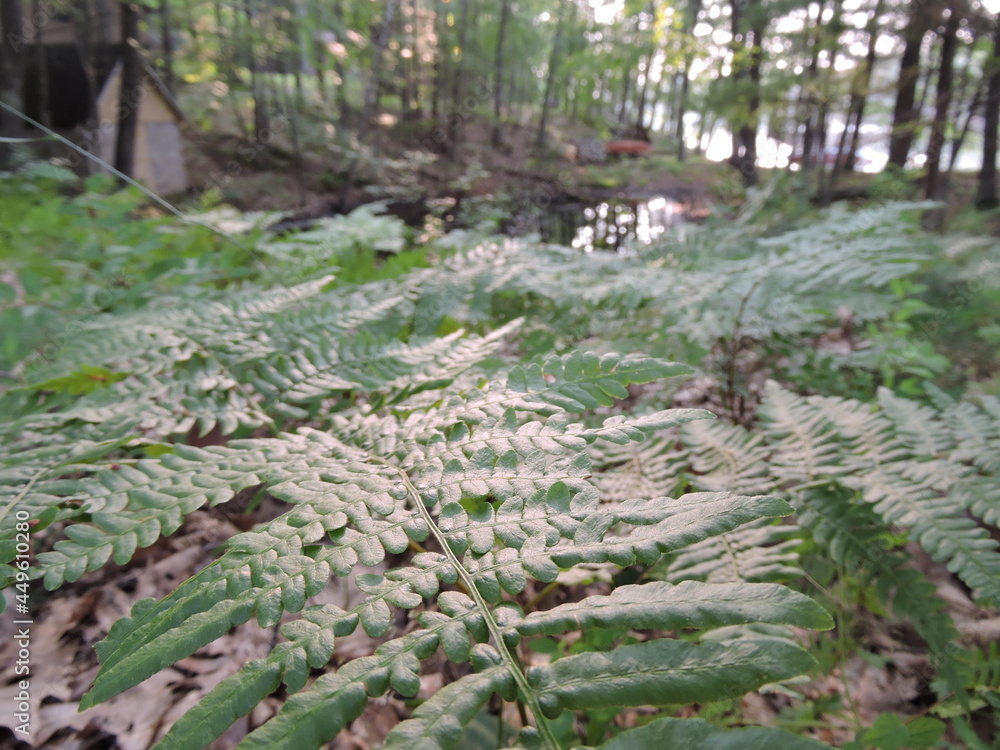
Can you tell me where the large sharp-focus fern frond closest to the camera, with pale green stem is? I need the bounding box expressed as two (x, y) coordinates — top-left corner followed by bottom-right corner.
(11, 353), (832, 750)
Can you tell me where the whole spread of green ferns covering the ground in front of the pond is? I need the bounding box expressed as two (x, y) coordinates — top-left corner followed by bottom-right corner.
(0, 167), (1000, 748)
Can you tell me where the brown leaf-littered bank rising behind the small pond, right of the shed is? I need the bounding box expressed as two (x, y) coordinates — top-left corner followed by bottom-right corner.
(187, 107), (741, 220)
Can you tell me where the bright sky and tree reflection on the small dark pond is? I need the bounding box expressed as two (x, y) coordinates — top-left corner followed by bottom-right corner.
(539, 196), (683, 253)
